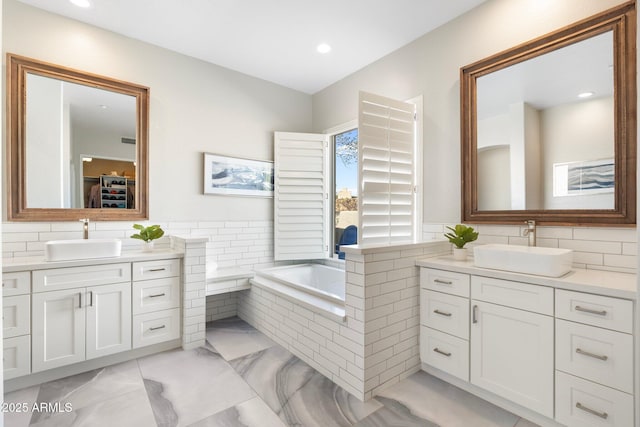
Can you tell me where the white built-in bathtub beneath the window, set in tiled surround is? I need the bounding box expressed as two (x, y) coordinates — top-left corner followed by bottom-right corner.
(251, 264), (345, 320)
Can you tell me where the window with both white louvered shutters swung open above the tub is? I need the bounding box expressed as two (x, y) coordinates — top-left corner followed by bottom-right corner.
(274, 92), (422, 261)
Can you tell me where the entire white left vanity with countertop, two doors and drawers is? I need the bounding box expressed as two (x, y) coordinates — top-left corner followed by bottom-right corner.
(2, 250), (184, 389)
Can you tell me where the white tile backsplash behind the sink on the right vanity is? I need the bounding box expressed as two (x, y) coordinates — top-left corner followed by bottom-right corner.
(422, 223), (638, 273)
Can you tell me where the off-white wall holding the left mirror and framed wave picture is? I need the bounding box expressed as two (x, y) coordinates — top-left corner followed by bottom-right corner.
(2, 0), (311, 221)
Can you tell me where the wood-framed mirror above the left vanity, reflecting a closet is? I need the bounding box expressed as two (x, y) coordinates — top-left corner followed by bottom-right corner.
(6, 53), (149, 221)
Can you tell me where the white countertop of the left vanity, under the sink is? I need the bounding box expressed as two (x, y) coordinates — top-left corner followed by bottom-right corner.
(2, 249), (184, 273)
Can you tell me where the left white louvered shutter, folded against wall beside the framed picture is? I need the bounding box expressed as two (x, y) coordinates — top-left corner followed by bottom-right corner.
(274, 132), (329, 261)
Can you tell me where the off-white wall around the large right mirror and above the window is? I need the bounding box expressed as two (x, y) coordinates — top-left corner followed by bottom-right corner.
(313, 0), (624, 223)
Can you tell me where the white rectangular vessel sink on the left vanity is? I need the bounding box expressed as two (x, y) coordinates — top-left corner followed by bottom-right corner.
(44, 239), (122, 261)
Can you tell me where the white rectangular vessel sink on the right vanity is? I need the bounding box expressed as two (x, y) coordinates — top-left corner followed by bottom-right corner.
(473, 244), (573, 277)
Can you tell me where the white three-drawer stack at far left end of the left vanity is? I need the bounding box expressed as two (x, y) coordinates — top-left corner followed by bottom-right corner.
(2, 271), (31, 380)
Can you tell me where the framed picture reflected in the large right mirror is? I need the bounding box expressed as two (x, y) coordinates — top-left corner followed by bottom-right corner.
(553, 159), (615, 197)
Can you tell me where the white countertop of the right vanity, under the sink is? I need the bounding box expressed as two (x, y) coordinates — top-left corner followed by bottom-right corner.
(416, 256), (638, 300)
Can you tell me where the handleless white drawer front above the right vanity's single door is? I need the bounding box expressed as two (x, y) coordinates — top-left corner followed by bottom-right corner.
(471, 276), (553, 316)
